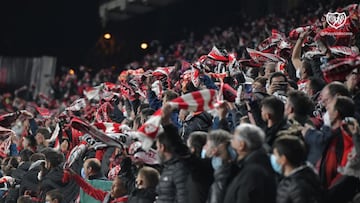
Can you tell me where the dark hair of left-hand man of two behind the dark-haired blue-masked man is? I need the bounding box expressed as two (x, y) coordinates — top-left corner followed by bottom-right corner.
(261, 96), (285, 121)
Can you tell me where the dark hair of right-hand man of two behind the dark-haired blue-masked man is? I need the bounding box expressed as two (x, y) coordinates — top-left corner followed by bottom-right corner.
(287, 91), (314, 116)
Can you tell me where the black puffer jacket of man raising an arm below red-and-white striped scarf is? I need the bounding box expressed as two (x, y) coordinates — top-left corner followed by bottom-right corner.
(156, 157), (189, 203)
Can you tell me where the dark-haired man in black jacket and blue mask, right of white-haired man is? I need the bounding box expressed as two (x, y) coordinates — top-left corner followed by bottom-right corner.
(273, 136), (323, 203)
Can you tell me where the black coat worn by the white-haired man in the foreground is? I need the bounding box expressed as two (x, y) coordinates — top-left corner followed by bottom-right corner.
(223, 149), (276, 203)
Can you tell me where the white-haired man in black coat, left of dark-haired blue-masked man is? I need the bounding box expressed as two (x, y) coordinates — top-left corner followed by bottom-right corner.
(224, 124), (276, 203)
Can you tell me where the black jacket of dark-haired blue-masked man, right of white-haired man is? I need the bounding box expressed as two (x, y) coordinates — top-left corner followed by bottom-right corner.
(276, 166), (323, 203)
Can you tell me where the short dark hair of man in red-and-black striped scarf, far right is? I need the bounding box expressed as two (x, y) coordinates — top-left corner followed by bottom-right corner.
(334, 96), (355, 119)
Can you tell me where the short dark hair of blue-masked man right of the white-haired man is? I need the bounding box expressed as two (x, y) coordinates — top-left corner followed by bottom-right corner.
(273, 136), (307, 167)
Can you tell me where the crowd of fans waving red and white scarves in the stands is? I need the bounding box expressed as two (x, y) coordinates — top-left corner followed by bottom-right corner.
(0, 0), (360, 203)
